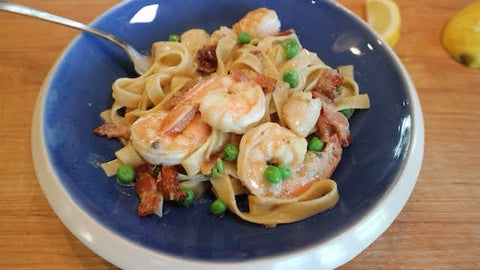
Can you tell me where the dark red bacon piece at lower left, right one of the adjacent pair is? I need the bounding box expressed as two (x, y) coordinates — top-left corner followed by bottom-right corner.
(157, 165), (187, 202)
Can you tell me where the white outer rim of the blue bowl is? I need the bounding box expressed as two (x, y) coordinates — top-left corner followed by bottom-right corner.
(31, 0), (424, 269)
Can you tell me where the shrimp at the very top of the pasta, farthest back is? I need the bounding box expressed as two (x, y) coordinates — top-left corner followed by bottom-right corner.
(232, 8), (281, 38)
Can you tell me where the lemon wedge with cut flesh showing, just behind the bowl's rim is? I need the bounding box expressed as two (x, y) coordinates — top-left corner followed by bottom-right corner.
(366, 0), (402, 47)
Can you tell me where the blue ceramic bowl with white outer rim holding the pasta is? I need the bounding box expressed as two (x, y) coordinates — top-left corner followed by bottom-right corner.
(32, 0), (423, 269)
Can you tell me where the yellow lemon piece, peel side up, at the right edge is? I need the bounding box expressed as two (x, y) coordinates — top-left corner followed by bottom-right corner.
(442, 1), (480, 69)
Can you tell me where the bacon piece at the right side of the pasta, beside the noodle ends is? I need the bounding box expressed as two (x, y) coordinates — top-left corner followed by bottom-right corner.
(316, 95), (352, 147)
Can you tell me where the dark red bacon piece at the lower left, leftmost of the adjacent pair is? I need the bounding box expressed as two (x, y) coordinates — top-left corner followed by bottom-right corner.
(135, 164), (159, 216)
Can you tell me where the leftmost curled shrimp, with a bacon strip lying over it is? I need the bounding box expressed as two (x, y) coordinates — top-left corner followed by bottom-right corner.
(131, 111), (211, 165)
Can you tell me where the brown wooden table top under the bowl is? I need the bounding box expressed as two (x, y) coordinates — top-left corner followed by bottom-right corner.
(0, 0), (480, 269)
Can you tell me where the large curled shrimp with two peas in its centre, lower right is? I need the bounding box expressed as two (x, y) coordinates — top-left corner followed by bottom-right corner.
(237, 122), (342, 198)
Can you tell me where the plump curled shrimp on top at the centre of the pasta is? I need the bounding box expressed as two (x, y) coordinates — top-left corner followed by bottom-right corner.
(200, 76), (266, 134)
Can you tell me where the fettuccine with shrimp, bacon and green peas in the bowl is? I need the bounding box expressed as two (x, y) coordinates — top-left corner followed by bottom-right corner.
(94, 8), (370, 226)
